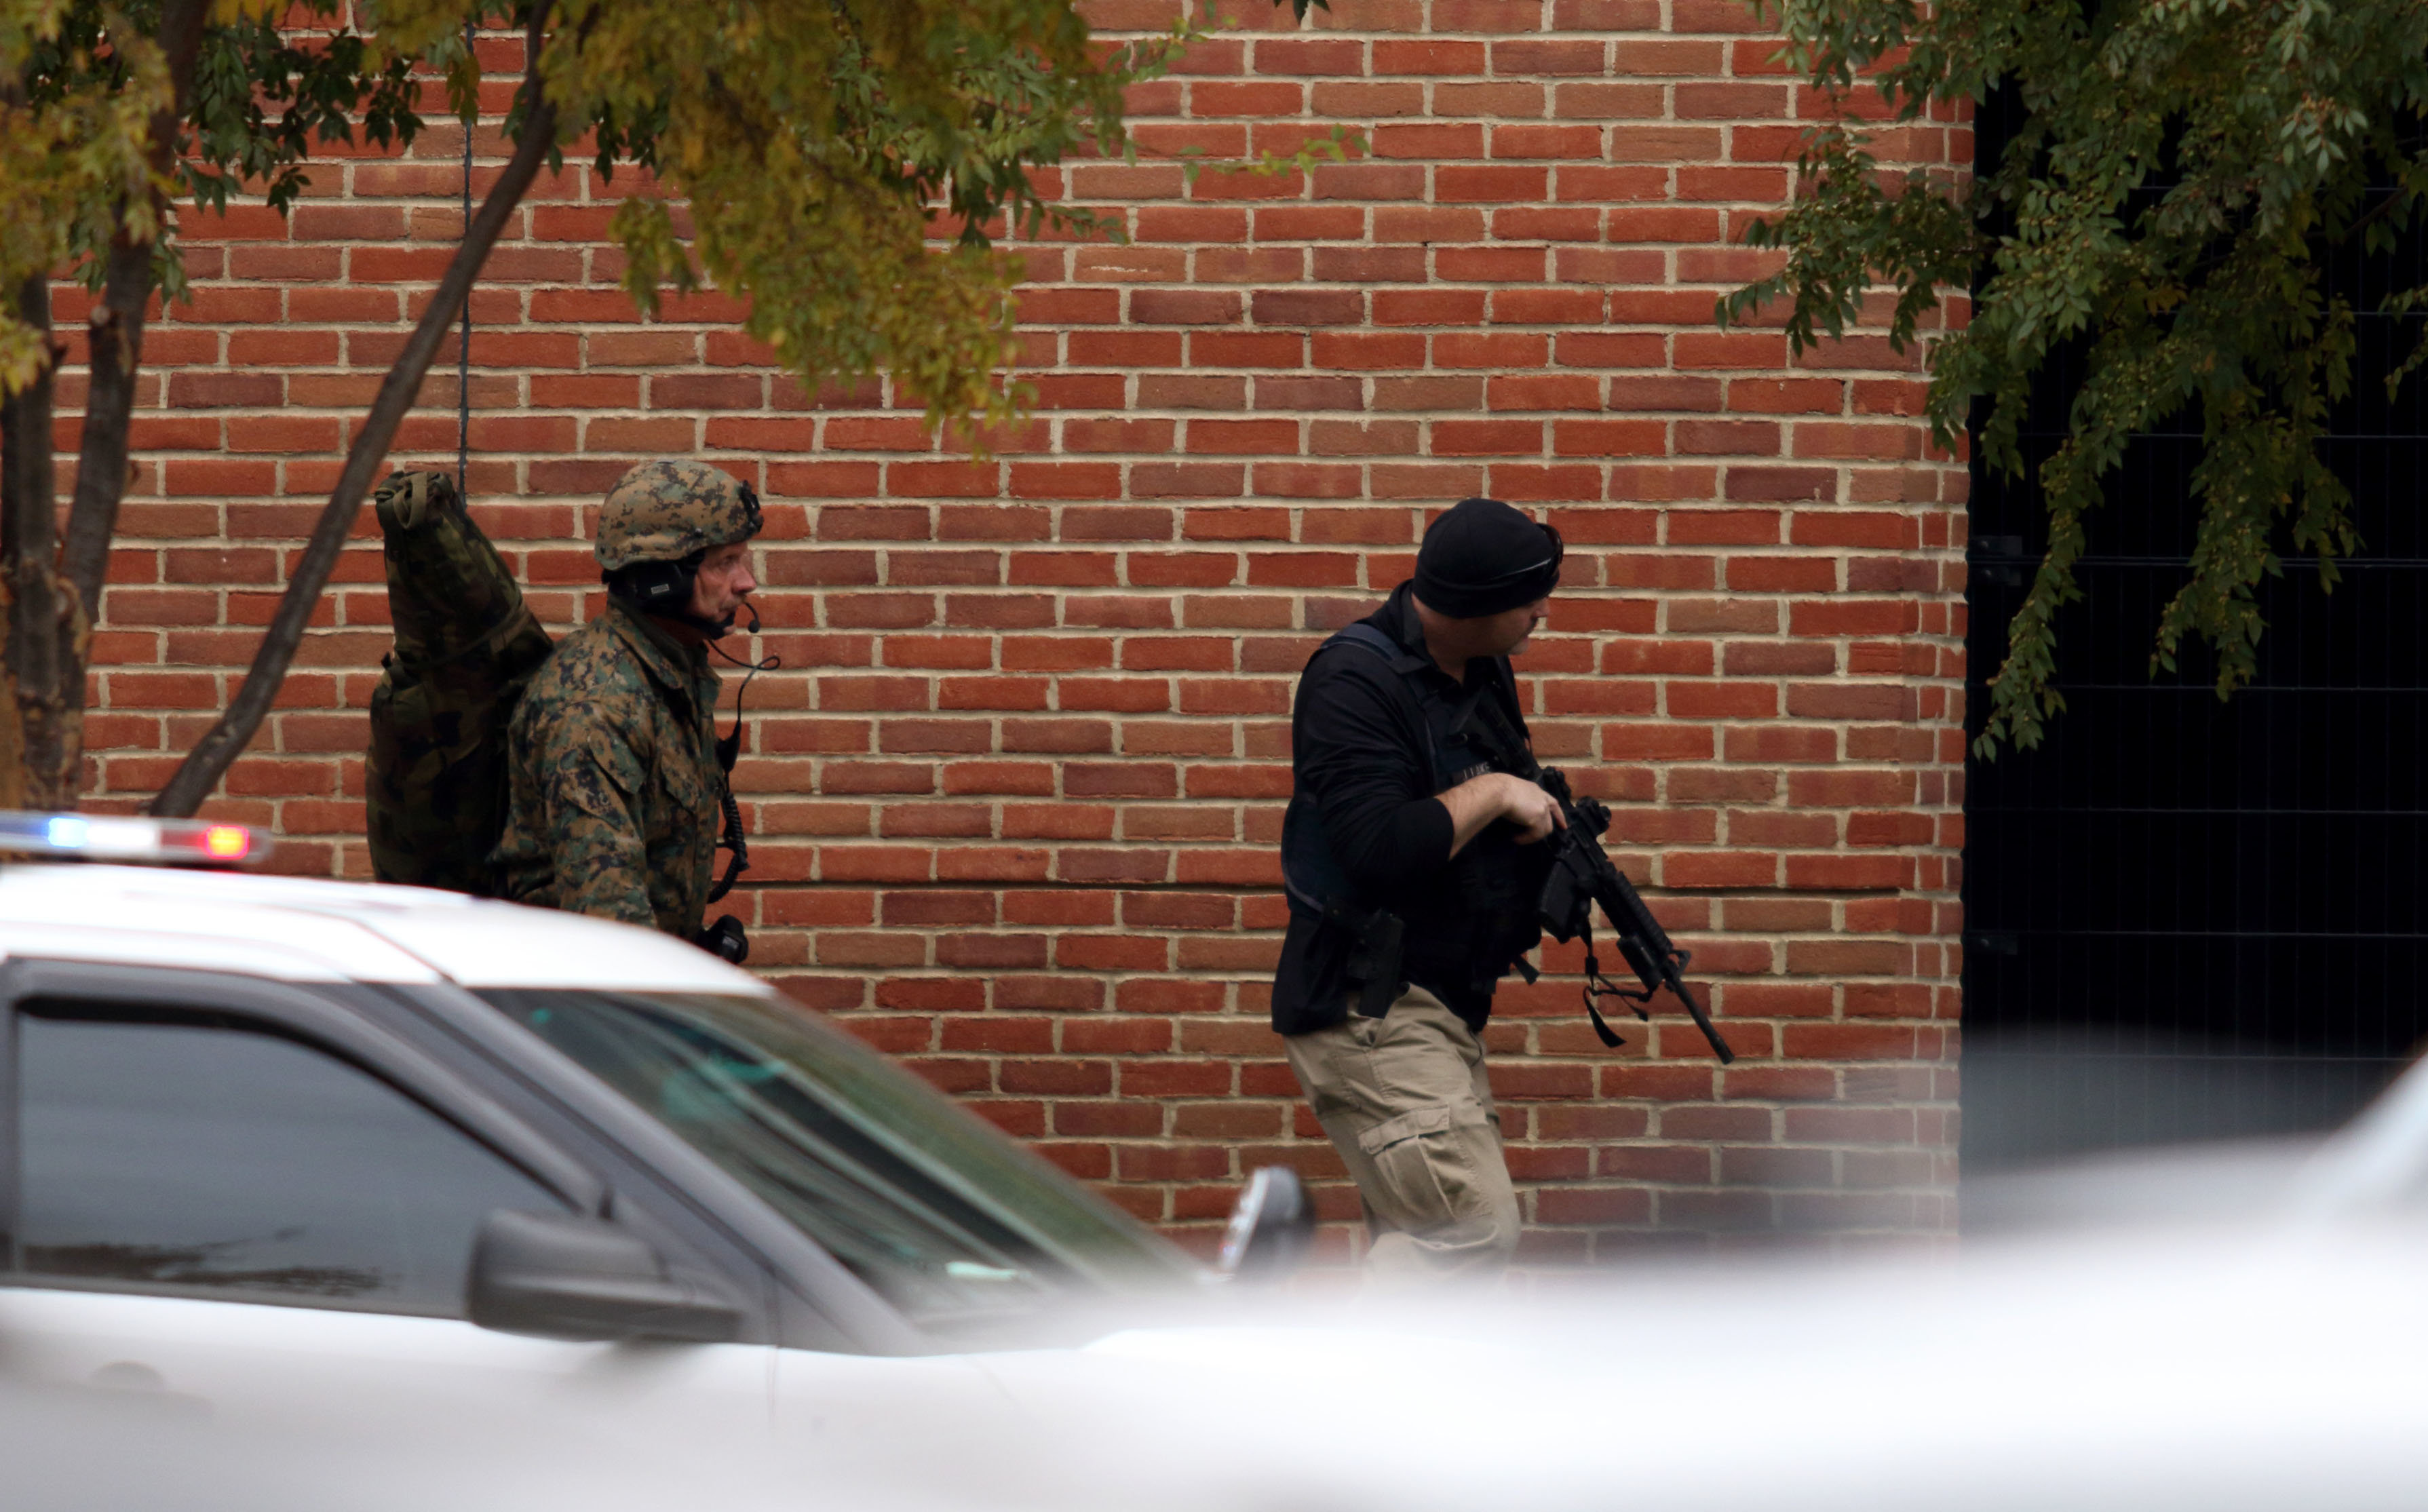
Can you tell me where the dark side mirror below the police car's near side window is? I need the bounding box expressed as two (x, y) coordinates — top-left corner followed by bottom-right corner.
(464, 1209), (743, 1344)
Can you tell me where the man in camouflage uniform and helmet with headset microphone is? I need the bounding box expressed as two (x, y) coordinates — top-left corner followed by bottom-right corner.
(493, 461), (760, 944)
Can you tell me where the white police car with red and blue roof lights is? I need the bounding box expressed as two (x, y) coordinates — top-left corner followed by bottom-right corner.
(0, 815), (1252, 1509)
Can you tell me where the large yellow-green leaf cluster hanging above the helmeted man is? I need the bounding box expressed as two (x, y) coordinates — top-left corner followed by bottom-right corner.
(379, 0), (1195, 437)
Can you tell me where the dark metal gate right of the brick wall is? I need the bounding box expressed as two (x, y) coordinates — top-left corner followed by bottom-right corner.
(1962, 112), (2428, 1175)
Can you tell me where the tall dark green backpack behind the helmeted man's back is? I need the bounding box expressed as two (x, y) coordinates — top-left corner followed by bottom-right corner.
(366, 473), (554, 895)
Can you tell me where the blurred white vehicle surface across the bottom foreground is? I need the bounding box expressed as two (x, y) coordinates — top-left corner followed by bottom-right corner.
(14, 1223), (2428, 1512)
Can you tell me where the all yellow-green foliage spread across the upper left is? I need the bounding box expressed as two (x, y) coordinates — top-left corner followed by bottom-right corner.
(0, 0), (1197, 423)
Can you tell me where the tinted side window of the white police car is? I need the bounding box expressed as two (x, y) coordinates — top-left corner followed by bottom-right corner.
(14, 1005), (566, 1318)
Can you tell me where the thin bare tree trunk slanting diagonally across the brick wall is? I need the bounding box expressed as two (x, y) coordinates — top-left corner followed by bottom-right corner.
(151, 29), (556, 818)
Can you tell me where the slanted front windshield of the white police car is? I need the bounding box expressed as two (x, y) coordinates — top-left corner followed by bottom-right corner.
(483, 990), (1199, 1327)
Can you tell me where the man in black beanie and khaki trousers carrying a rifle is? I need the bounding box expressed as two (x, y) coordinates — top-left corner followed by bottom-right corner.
(1272, 497), (1561, 1281)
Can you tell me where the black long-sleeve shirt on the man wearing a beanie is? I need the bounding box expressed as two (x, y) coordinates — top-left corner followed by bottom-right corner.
(1272, 585), (1525, 1034)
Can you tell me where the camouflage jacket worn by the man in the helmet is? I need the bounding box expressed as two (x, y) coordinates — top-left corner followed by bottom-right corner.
(493, 600), (724, 939)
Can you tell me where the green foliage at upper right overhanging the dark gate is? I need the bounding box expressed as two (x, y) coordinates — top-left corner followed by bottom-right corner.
(1719, 0), (2428, 755)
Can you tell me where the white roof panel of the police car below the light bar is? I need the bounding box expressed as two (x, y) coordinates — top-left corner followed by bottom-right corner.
(0, 864), (772, 995)
